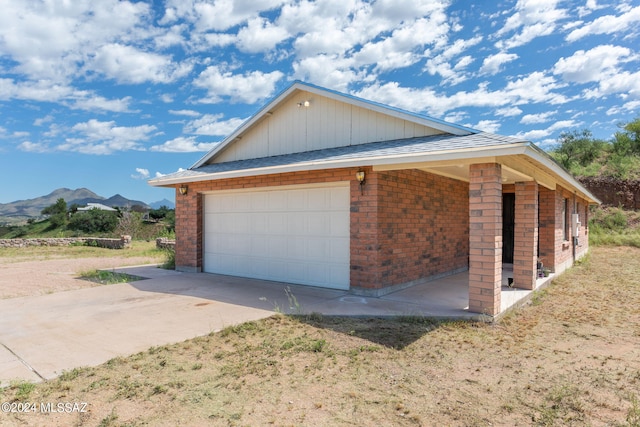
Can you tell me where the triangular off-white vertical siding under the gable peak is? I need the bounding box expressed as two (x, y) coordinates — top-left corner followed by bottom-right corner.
(213, 92), (442, 163)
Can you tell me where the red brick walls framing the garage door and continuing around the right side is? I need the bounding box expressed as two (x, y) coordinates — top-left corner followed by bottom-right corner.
(176, 168), (469, 289)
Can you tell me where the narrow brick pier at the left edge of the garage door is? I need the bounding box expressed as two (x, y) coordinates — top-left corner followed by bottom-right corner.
(175, 188), (203, 272)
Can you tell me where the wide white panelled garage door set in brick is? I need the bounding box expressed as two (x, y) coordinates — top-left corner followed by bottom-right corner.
(203, 183), (350, 289)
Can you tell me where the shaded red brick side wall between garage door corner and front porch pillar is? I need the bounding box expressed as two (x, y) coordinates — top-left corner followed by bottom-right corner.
(360, 170), (469, 288)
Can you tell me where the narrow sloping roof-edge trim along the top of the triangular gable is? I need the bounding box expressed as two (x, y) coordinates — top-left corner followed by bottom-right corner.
(190, 81), (478, 169)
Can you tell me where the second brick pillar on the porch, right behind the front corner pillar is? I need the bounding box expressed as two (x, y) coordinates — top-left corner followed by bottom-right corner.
(513, 181), (538, 289)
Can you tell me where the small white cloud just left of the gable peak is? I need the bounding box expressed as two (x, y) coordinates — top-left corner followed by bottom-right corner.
(194, 65), (284, 104)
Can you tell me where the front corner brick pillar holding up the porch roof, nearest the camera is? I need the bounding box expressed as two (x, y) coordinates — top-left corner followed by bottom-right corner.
(469, 163), (502, 316)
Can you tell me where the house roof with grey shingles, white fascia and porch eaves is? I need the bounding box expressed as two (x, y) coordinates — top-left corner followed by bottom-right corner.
(148, 82), (599, 203)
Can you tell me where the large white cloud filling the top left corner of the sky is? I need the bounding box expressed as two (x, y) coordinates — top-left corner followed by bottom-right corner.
(0, 0), (150, 83)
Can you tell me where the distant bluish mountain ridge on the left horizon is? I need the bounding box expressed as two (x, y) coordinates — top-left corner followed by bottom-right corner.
(0, 188), (150, 222)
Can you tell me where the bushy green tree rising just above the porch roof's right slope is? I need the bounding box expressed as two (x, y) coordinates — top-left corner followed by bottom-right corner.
(554, 129), (607, 169)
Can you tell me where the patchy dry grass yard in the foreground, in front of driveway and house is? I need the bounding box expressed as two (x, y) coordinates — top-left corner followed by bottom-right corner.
(0, 247), (640, 426)
